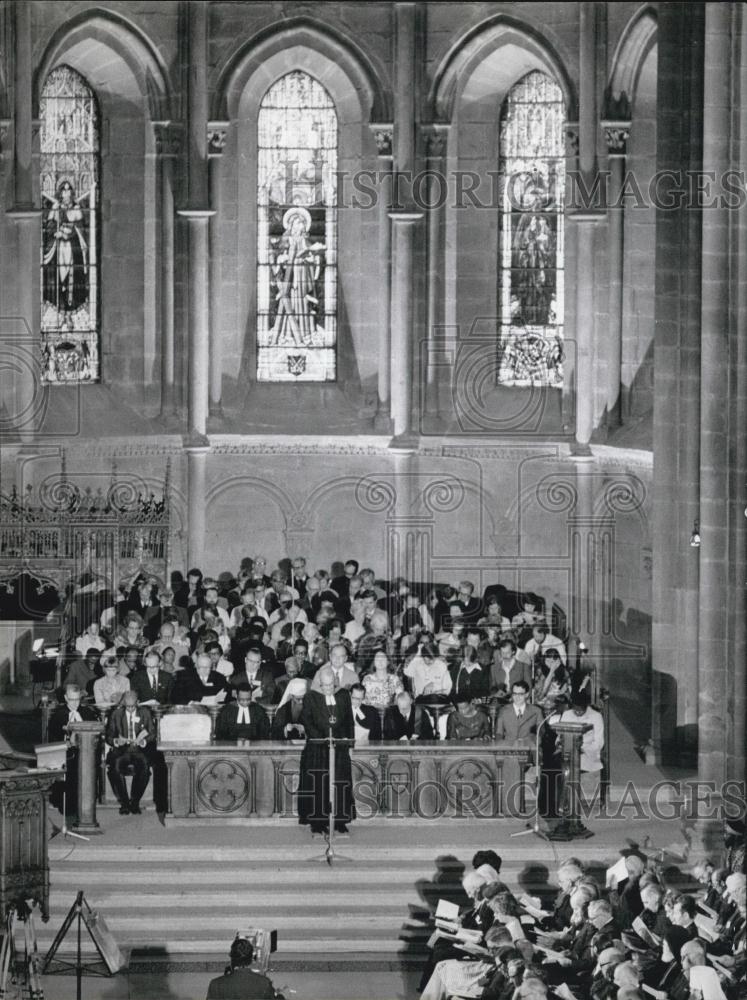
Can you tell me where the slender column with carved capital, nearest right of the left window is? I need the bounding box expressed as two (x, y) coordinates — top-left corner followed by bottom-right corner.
(153, 121), (181, 423)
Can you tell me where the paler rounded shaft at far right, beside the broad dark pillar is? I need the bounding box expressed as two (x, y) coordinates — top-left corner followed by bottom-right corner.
(698, 3), (732, 785)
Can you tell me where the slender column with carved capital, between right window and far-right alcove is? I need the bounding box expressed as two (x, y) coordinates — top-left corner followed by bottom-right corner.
(602, 121), (630, 428)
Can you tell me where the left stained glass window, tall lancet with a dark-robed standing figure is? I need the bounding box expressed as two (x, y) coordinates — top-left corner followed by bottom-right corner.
(40, 66), (100, 384)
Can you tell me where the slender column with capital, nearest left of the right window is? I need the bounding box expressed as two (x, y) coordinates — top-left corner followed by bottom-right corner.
(423, 122), (449, 429)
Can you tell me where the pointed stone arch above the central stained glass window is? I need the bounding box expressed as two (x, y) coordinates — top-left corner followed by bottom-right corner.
(212, 17), (393, 122)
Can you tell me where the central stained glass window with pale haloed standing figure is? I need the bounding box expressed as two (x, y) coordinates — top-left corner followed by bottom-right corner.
(257, 71), (337, 382)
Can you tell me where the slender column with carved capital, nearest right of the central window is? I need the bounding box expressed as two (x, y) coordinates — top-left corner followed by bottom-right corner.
(371, 123), (394, 434)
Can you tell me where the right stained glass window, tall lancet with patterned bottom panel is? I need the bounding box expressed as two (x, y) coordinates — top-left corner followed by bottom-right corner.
(498, 72), (565, 386)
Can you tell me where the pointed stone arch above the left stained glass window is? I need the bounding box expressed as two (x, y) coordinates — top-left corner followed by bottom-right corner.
(33, 8), (173, 121)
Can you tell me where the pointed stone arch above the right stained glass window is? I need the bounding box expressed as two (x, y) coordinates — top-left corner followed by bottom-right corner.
(428, 14), (576, 122)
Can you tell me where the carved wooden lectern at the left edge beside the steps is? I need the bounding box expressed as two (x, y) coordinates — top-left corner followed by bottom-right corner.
(0, 770), (64, 921)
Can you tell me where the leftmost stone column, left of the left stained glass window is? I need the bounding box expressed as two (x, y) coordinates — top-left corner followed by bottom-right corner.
(7, 0), (41, 445)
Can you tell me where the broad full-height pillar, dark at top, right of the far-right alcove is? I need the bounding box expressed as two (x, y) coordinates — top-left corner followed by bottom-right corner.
(647, 3), (704, 765)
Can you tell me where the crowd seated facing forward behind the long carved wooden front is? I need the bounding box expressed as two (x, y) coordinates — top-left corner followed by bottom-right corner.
(50, 558), (604, 813)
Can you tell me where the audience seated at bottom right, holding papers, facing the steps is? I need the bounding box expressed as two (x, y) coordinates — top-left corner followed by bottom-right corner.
(420, 821), (747, 1000)
